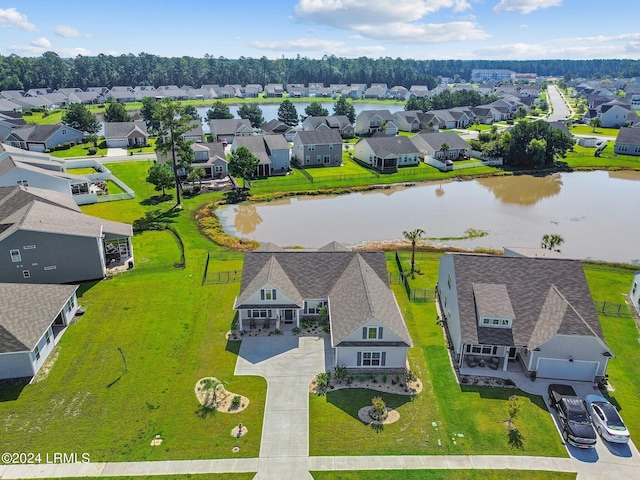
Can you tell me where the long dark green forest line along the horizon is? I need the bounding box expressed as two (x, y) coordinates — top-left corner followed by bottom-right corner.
(0, 52), (640, 90)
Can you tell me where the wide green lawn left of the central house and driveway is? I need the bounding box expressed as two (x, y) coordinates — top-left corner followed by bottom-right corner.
(0, 162), (266, 464)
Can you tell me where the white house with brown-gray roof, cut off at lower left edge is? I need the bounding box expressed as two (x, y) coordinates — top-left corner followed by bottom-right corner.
(0, 283), (78, 380)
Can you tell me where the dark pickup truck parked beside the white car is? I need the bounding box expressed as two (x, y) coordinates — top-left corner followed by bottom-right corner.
(549, 383), (596, 448)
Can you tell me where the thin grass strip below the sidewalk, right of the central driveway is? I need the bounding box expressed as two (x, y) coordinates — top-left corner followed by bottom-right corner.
(311, 470), (577, 480)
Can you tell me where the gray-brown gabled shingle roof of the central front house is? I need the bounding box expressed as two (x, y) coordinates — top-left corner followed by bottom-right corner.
(235, 249), (411, 346)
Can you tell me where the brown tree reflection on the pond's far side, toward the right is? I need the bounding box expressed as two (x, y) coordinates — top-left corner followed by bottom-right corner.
(478, 173), (562, 205)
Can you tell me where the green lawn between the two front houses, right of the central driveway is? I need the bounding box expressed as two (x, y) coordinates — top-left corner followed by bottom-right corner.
(309, 253), (566, 456)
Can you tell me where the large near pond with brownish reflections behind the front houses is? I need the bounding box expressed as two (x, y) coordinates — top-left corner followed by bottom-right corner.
(217, 171), (640, 263)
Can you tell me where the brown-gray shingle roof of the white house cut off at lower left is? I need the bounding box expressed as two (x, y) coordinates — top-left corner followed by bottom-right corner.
(0, 283), (78, 353)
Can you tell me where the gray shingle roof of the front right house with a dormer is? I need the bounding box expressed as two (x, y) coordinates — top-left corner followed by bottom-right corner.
(444, 254), (604, 349)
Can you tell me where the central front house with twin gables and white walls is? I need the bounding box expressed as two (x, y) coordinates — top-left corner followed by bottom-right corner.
(233, 244), (412, 371)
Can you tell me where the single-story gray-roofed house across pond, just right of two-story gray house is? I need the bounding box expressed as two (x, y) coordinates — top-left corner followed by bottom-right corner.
(353, 134), (420, 172)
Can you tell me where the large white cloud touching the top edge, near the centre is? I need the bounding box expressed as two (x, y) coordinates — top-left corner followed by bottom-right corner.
(295, 0), (471, 29)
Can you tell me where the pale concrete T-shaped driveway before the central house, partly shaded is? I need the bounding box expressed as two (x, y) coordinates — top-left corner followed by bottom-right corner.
(235, 335), (333, 480)
